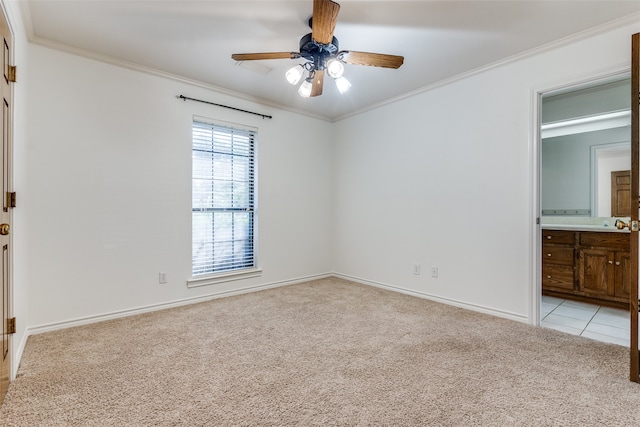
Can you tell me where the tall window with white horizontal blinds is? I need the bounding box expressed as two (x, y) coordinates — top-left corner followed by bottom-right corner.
(192, 121), (256, 278)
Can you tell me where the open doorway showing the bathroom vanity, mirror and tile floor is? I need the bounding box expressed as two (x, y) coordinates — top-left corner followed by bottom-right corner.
(537, 73), (631, 346)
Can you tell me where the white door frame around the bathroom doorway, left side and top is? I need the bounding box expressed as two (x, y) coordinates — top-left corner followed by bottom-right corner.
(529, 67), (631, 326)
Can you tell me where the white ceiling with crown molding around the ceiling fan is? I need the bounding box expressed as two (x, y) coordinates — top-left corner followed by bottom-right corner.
(21, 0), (640, 120)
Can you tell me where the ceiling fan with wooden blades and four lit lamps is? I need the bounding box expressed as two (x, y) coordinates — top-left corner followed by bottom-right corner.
(231, 0), (404, 97)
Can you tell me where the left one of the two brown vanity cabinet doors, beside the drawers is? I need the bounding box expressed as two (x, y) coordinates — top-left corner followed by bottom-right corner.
(579, 249), (615, 296)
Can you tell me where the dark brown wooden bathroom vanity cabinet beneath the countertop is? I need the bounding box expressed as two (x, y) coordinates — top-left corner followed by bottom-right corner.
(542, 230), (630, 306)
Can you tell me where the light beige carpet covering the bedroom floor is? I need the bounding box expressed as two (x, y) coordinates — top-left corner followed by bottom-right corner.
(0, 279), (640, 426)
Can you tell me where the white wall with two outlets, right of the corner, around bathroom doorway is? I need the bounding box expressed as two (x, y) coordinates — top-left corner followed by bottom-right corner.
(333, 20), (640, 320)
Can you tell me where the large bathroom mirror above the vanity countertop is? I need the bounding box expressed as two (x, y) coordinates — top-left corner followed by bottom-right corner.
(541, 75), (631, 217)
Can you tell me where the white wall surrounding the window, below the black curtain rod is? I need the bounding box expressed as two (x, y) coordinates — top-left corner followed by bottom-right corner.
(27, 45), (332, 331)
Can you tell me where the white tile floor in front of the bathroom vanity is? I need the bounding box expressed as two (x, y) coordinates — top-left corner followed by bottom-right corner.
(540, 295), (630, 347)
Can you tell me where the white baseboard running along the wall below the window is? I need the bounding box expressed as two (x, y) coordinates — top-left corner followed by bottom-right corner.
(27, 273), (333, 338)
